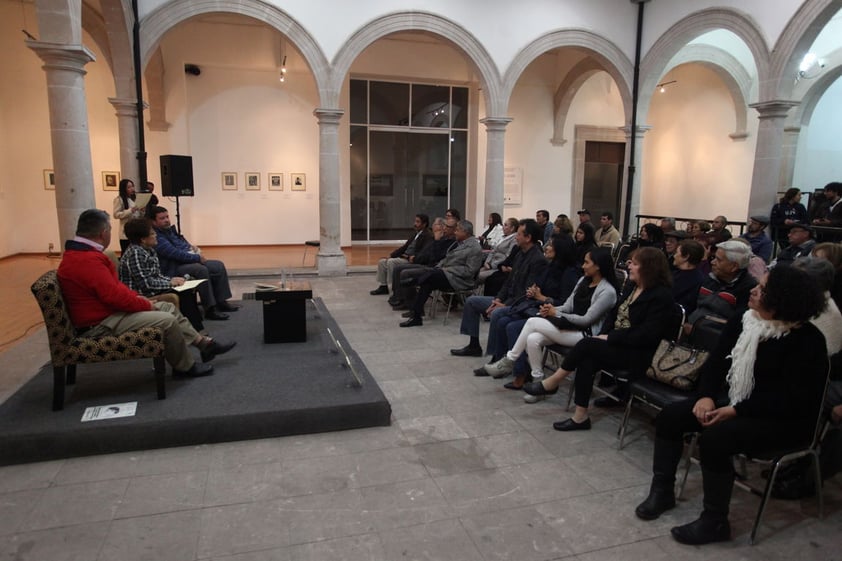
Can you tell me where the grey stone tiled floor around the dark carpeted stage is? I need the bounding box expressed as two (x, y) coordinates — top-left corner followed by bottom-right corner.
(0, 275), (842, 561)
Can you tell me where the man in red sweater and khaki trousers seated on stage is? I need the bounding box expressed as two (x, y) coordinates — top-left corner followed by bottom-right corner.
(57, 209), (236, 377)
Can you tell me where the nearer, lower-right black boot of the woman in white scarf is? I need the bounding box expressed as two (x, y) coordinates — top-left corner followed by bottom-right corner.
(670, 468), (734, 545)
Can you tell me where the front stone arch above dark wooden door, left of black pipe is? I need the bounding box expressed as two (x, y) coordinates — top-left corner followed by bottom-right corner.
(501, 29), (634, 122)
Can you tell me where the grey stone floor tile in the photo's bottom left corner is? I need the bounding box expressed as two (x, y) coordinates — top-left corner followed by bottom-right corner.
(0, 522), (108, 561)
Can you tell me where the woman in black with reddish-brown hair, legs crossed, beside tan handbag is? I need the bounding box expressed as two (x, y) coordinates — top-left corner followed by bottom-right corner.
(523, 247), (677, 431)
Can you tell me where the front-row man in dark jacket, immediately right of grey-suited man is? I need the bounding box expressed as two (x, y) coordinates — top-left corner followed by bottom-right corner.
(450, 218), (547, 356)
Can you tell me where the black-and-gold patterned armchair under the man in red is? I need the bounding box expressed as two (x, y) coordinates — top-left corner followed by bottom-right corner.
(31, 271), (166, 411)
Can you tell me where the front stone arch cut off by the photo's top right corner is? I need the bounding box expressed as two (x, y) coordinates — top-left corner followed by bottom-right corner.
(760, 0), (842, 99)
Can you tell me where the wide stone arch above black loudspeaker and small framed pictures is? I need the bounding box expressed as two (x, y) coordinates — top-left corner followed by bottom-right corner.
(140, 0), (330, 99)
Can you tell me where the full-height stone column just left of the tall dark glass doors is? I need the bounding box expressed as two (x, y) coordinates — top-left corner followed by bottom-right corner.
(313, 109), (347, 276)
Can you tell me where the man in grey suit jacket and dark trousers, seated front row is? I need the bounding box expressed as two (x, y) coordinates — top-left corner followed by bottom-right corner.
(400, 220), (482, 327)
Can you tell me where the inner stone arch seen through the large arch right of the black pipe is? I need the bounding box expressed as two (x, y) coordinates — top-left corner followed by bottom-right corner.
(664, 44), (752, 140)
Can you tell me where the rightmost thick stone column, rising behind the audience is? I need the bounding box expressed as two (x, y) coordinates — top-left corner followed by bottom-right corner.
(746, 100), (798, 216)
